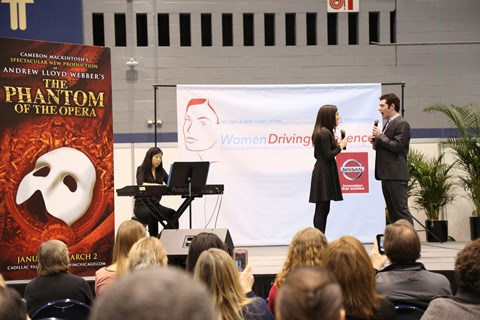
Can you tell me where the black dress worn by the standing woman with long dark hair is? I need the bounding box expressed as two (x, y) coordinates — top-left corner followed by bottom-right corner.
(309, 128), (343, 203)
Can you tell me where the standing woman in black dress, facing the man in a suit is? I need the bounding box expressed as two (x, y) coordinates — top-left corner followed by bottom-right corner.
(309, 105), (347, 233)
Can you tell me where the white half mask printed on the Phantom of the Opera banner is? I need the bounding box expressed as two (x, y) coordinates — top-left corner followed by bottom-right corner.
(16, 147), (96, 226)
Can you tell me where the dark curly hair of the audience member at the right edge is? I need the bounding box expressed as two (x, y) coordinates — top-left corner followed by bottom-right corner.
(455, 239), (480, 295)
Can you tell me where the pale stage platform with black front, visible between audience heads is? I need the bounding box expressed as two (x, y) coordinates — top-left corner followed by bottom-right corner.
(246, 241), (467, 298)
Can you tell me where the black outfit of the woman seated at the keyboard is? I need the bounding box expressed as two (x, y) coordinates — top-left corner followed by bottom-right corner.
(133, 166), (178, 237)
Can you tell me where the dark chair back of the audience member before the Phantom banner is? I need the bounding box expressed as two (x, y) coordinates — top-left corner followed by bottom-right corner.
(32, 299), (90, 320)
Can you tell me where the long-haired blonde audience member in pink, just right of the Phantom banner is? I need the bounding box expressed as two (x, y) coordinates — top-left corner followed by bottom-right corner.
(95, 220), (147, 296)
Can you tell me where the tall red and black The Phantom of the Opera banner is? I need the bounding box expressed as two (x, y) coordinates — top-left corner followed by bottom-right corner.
(0, 38), (114, 280)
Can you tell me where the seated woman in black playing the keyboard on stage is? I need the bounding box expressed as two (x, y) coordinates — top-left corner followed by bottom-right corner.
(133, 147), (178, 237)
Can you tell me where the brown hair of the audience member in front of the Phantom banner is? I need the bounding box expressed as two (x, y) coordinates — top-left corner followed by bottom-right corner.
(37, 239), (70, 276)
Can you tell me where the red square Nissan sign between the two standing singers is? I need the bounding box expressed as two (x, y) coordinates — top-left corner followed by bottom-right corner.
(336, 152), (370, 193)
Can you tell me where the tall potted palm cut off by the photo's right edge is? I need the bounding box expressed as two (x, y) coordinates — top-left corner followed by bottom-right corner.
(425, 104), (480, 240)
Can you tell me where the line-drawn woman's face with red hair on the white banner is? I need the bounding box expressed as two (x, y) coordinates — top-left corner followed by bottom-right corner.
(183, 99), (219, 151)
